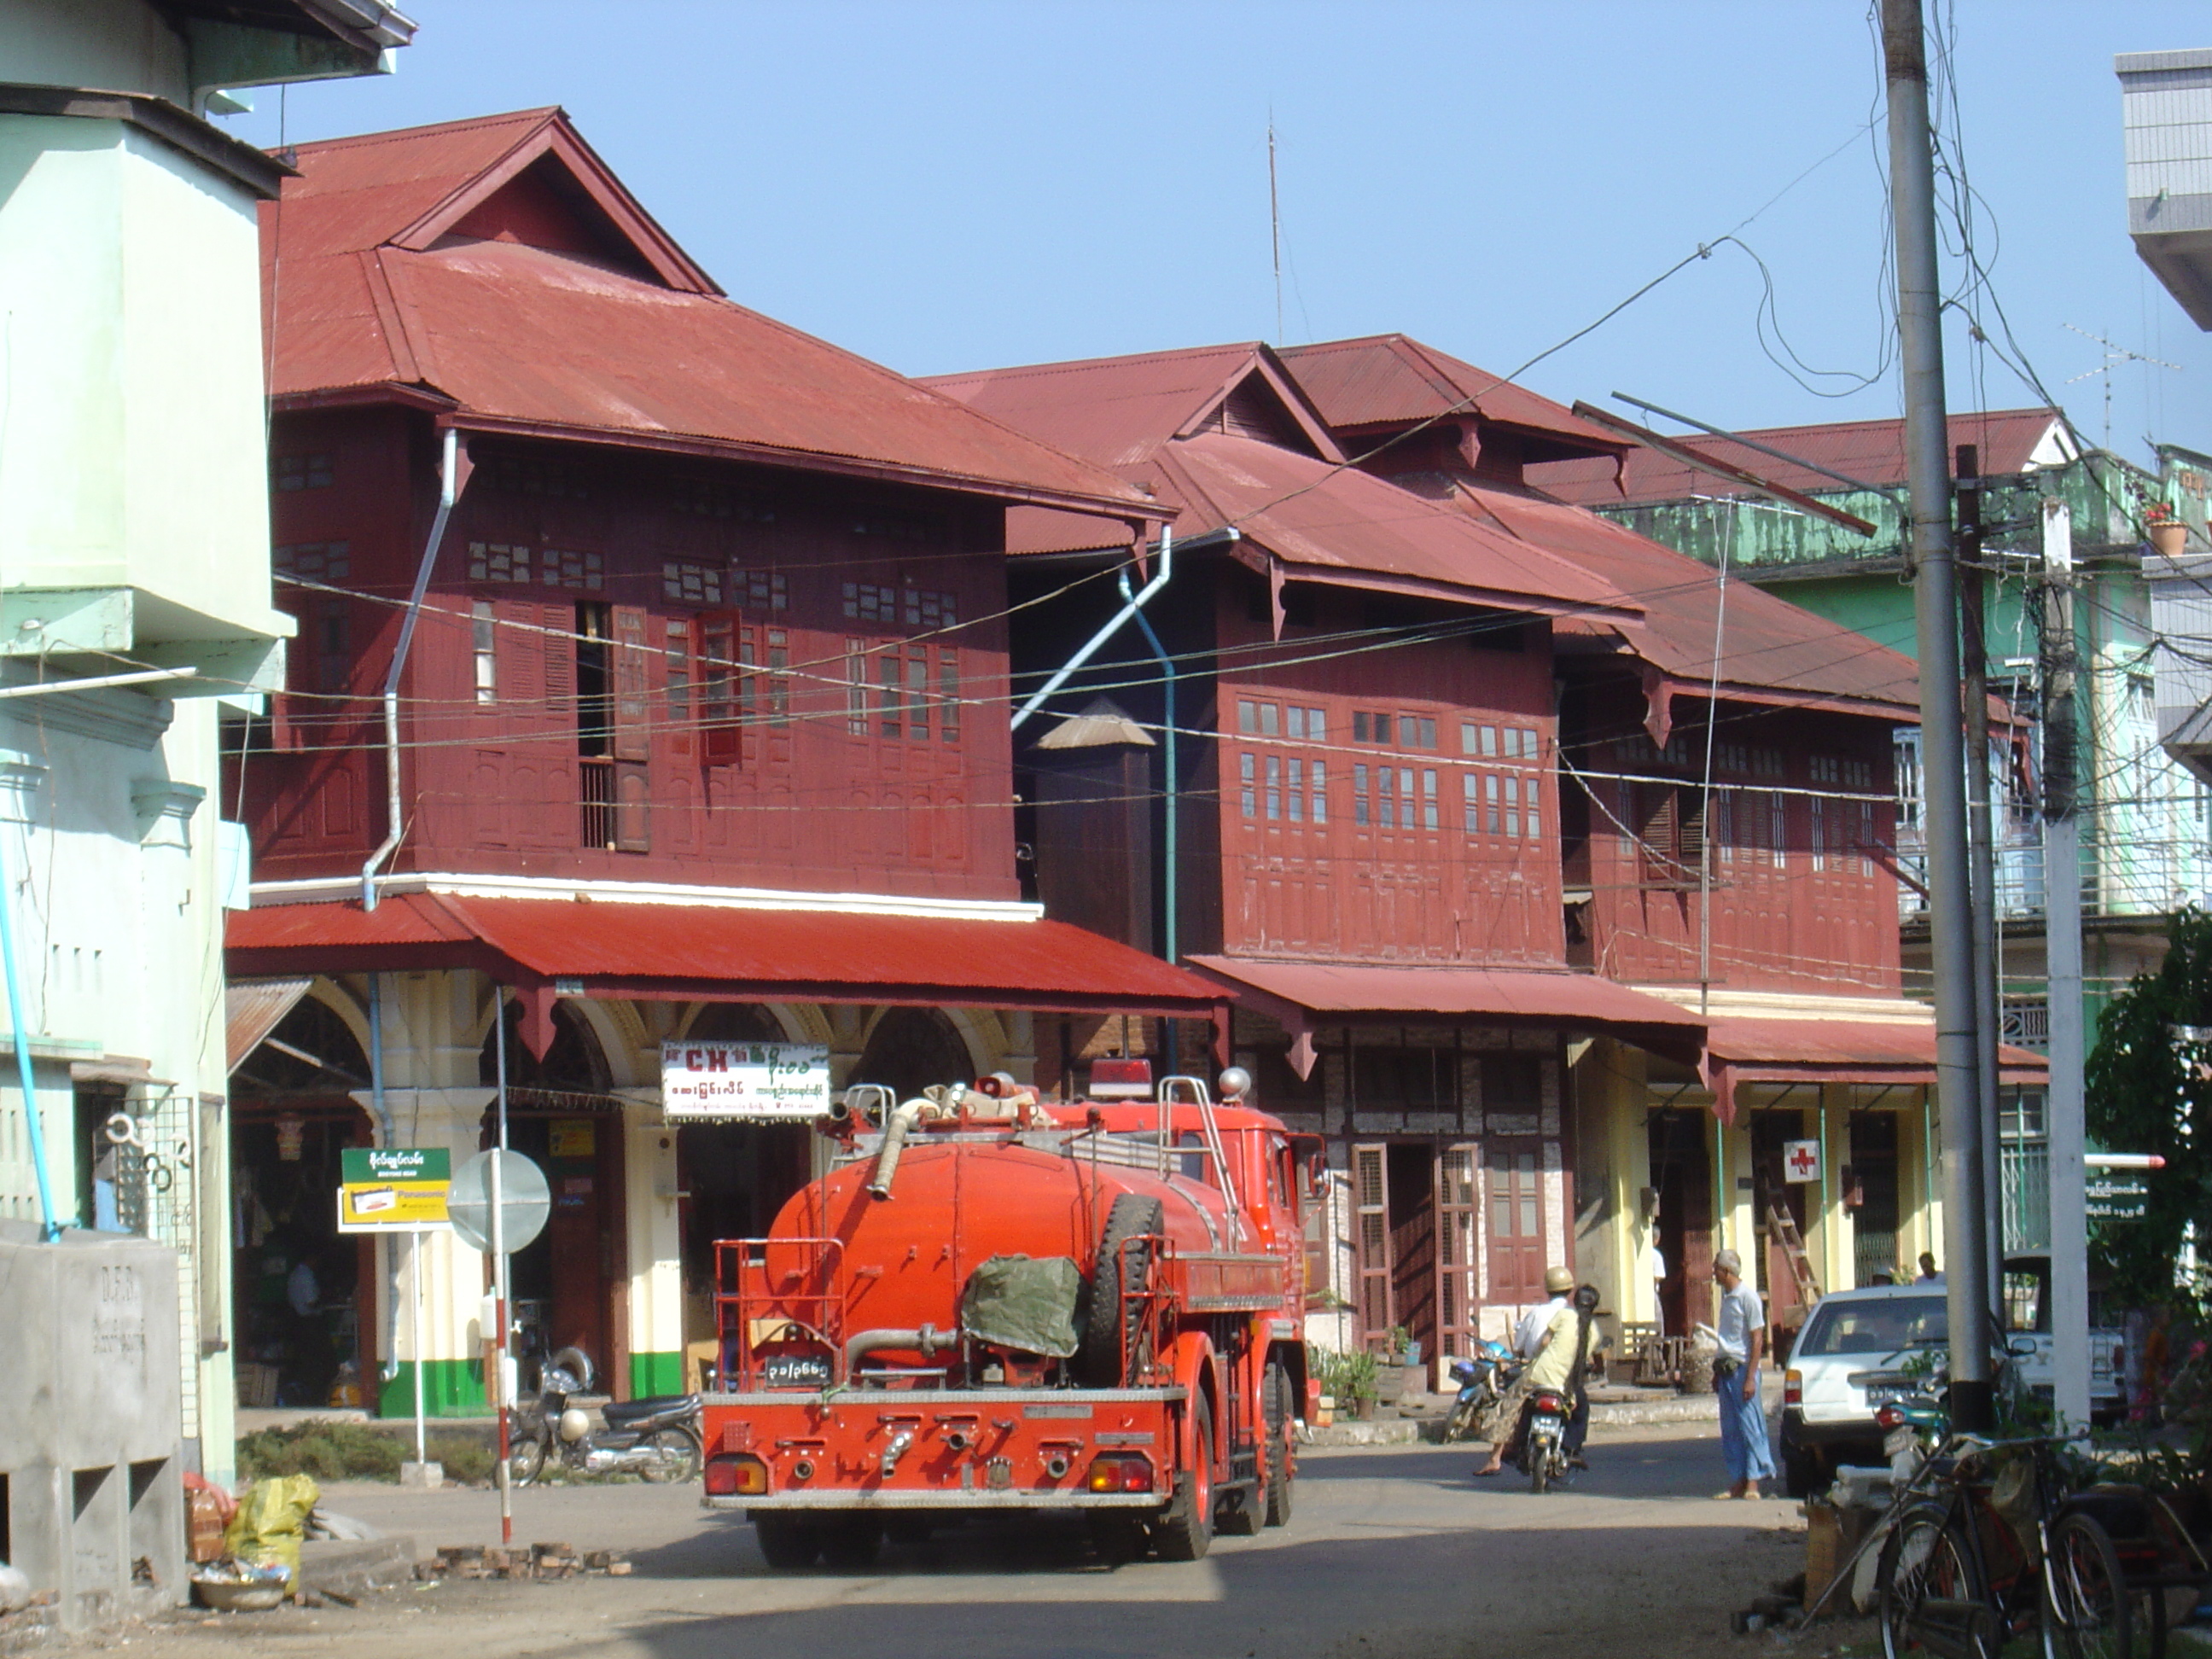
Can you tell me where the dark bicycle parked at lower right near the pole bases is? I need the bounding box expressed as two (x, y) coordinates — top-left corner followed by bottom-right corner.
(1876, 1434), (2132, 1659)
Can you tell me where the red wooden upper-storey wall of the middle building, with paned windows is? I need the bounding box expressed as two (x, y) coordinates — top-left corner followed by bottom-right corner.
(1214, 584), (1564, 967)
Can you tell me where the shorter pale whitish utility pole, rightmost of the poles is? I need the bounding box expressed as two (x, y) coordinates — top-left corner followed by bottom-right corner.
(2041, 498), (2088, 1429)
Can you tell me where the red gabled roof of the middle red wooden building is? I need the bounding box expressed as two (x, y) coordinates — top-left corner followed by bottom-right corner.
(929, 343), (1639, 621)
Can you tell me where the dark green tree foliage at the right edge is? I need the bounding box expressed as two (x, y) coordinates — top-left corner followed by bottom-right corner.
(2084, 907), (2212, 1305)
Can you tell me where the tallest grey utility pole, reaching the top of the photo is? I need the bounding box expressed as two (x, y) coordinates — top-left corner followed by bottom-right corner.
(1883, 0), (1995, 1429)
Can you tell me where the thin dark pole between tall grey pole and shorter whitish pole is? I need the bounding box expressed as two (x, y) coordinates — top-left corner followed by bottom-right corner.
(1955, 445), (2004, 1309)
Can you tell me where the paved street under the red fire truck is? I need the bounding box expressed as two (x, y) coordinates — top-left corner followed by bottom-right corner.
(138, 1424), (1802, 1659)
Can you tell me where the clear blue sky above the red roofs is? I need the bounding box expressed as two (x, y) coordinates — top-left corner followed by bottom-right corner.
(230, 0), (2212, 458)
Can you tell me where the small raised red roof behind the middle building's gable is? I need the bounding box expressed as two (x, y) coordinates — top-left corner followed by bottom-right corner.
(1277, 334), (1628, 457)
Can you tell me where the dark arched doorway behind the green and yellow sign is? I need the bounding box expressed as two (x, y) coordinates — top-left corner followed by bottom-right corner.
(230, 995), (376, 1407)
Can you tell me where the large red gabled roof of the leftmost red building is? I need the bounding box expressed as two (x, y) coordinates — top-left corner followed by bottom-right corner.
(261, 108), (1157, 518)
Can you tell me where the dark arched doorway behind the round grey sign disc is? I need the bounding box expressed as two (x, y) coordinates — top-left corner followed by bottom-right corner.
(475, 1002), (631, 1398)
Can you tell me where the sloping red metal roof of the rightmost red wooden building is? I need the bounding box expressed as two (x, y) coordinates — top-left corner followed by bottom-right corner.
(1458, 478), (1920, 719)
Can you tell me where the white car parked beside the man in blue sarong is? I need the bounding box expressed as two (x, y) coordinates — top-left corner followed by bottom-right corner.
(1781, 1285), (1951, 1498)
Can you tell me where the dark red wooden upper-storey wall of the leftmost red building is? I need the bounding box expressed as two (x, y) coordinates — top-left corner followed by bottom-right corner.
(232, 411), (1016, 898)
